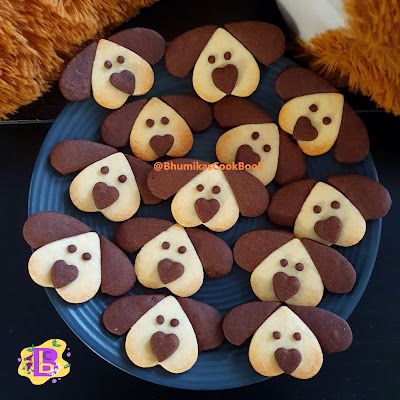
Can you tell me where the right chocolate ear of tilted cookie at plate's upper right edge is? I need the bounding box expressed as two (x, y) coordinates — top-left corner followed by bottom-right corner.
(334, 103), (369, 164)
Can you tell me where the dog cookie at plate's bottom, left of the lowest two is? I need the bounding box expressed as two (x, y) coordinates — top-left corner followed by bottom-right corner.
(103, 295), (223, 374)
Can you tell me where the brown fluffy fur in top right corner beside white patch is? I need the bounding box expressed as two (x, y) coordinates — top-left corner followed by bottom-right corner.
(302, 0), (400, 115)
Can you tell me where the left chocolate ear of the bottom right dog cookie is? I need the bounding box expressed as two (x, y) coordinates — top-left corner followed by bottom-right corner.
(222, 301), (281, 346)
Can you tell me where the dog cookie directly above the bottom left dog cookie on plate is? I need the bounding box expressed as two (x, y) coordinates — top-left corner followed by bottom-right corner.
(115, 218), (233, 297)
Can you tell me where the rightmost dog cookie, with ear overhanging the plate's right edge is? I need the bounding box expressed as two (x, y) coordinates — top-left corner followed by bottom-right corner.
(268, 175), (392, 247)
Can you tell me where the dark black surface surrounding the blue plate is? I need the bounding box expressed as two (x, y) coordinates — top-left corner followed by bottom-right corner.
(0, 0), (400, 400)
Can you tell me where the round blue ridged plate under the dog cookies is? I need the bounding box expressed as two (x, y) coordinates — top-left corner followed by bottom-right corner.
(29, 58), (381, 390)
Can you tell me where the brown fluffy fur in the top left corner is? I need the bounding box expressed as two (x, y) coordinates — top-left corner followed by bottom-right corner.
(0, 0), (155, 119)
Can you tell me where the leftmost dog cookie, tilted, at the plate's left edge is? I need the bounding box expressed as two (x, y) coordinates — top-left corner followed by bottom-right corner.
(23, 211), (136, 303)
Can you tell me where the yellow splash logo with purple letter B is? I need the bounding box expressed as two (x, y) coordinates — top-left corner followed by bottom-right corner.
(18, 339), (71, 385)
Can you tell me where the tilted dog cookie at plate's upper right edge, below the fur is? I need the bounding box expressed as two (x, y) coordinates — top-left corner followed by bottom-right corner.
(275, 67), (369, 164)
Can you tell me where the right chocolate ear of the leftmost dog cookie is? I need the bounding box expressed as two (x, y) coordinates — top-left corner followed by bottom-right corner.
(100, 236), (136, 296)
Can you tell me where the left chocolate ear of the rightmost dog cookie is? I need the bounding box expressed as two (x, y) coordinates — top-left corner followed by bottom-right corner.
(268, 179), (317, 226)
